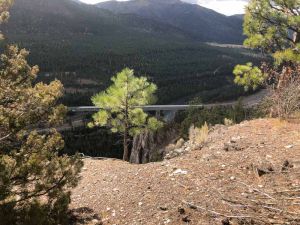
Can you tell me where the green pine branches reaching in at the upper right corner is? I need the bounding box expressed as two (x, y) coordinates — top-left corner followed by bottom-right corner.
(234, 0), (300, 89)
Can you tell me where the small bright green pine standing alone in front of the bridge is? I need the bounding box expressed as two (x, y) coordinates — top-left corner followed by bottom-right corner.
(91, 68), (162, 161)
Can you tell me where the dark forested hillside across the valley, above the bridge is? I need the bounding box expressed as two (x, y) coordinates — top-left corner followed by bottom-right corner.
(3, 0), (255, 105)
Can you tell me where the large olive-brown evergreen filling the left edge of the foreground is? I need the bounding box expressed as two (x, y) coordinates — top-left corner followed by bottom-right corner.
(0, 0), (82, 225)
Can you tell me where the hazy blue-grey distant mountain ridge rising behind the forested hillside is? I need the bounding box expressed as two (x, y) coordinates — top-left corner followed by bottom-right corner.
(96, 0), (244, 44)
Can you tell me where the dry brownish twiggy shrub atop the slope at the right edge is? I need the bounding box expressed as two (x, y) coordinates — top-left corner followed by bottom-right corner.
(261, 78), (300, 118)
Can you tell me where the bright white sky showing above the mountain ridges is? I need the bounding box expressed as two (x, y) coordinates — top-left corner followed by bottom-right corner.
(80, 0), (248, 15)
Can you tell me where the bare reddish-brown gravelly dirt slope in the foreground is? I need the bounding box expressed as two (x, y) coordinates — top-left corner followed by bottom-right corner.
(72, 119), (300, 225)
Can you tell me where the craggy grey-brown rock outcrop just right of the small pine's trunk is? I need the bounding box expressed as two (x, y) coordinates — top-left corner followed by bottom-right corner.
(130, 127), (178, 164)
